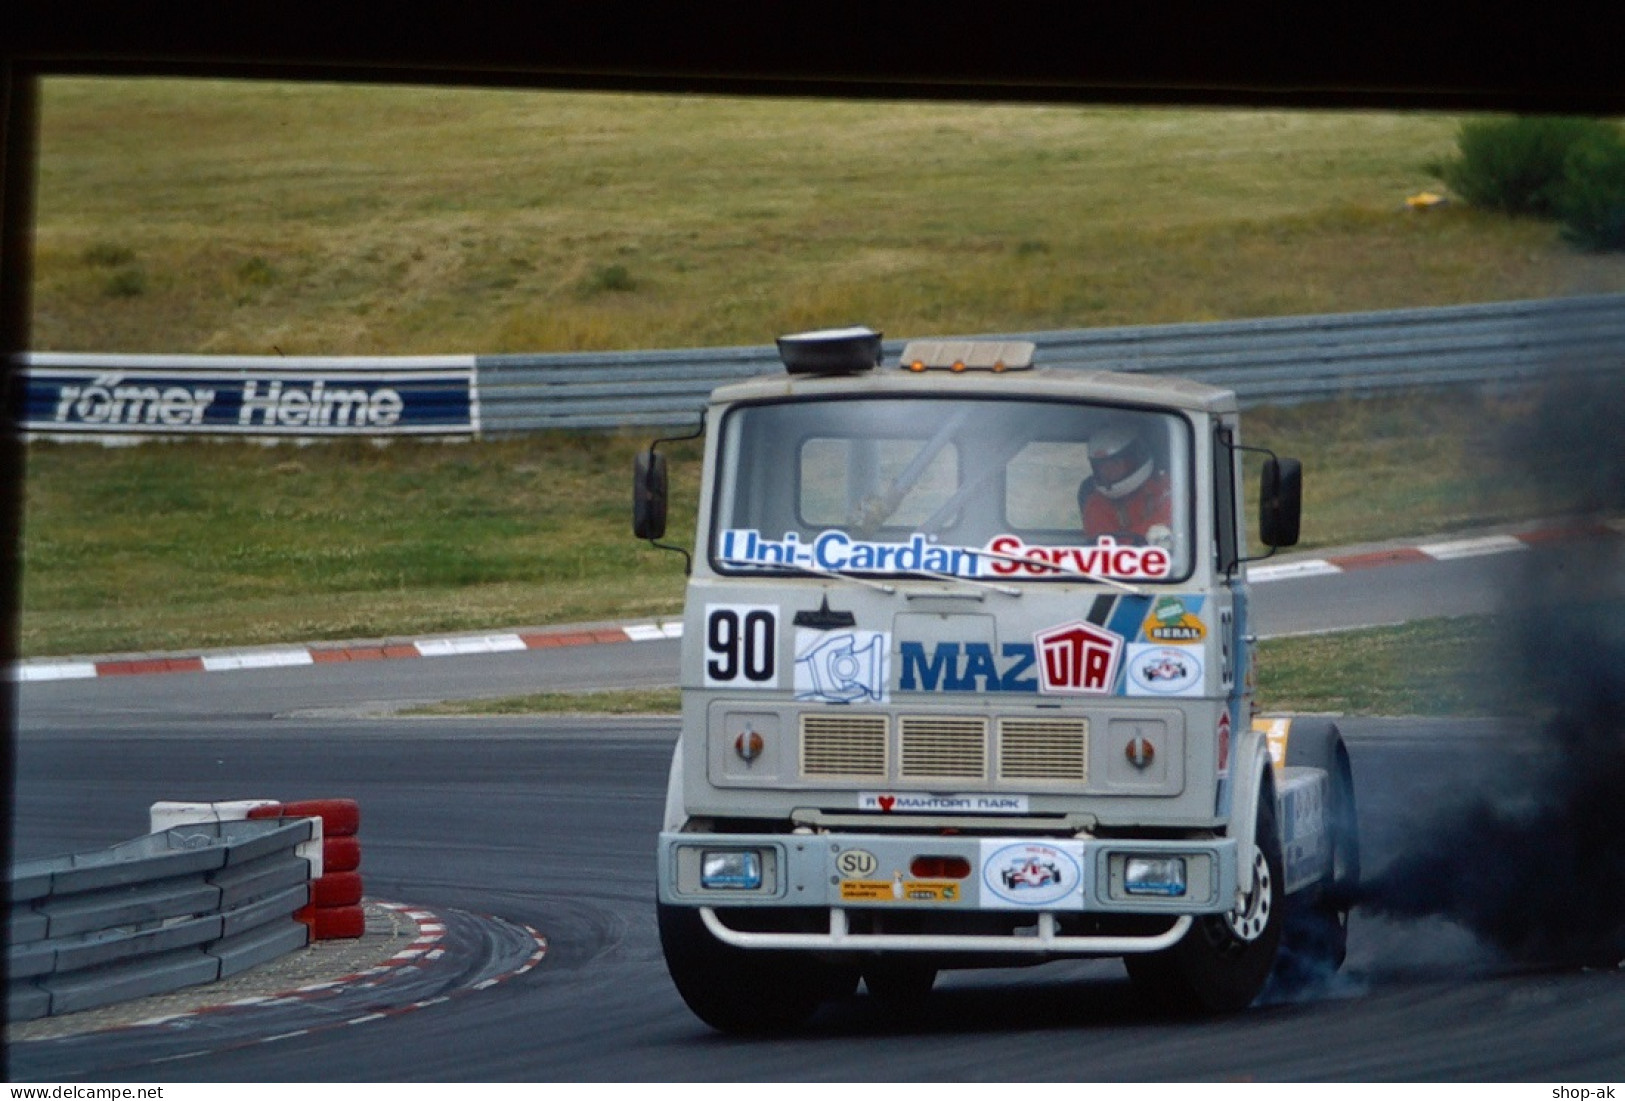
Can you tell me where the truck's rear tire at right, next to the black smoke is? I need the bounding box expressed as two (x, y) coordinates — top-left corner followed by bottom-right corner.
(1276, 723), (1360, 992)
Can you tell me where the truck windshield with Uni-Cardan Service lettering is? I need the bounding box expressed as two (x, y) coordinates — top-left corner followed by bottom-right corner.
(710, 398), (1193, 581)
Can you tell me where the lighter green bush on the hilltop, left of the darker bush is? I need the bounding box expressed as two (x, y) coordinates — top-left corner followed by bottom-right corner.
(1437, 117), (1619, 216)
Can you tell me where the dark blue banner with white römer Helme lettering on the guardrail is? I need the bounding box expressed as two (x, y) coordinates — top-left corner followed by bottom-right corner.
(21, 357), (479, 435)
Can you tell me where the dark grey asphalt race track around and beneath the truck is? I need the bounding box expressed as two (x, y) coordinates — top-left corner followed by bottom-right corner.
(8, 544), (1625, 1085)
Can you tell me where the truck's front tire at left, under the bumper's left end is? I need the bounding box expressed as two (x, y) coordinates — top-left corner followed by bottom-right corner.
(658, 905), (838, 1034)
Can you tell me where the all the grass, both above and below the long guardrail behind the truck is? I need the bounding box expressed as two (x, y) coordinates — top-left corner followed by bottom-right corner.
(21, 78), (1625, 708)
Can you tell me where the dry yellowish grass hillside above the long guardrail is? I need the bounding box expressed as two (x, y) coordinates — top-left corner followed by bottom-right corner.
(36, 78), (1625, 354)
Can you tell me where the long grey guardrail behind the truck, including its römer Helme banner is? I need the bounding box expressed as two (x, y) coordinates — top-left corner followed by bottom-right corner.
(23, 296), (1625, 437)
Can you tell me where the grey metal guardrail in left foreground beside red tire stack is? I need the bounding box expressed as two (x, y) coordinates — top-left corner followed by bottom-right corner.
(7, 818), (315, 1021)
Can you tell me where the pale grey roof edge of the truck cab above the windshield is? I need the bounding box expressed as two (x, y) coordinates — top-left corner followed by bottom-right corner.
(712, 367), (1238, 412)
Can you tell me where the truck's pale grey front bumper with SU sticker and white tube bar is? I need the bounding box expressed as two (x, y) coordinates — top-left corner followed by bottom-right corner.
(660, 833), (1237, 953)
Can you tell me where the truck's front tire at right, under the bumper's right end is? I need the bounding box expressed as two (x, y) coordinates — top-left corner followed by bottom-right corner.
(1123, 784), (1285, 1015)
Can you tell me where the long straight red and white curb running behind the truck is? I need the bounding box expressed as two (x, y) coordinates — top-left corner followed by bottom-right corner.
(11, 520), (1625, 680)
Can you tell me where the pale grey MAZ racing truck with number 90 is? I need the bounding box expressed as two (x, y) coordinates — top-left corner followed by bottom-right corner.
(632, 326), (1359, 1033)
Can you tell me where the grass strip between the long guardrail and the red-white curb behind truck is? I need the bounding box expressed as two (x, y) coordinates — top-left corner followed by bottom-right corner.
(12, 395), (1565, 654)
